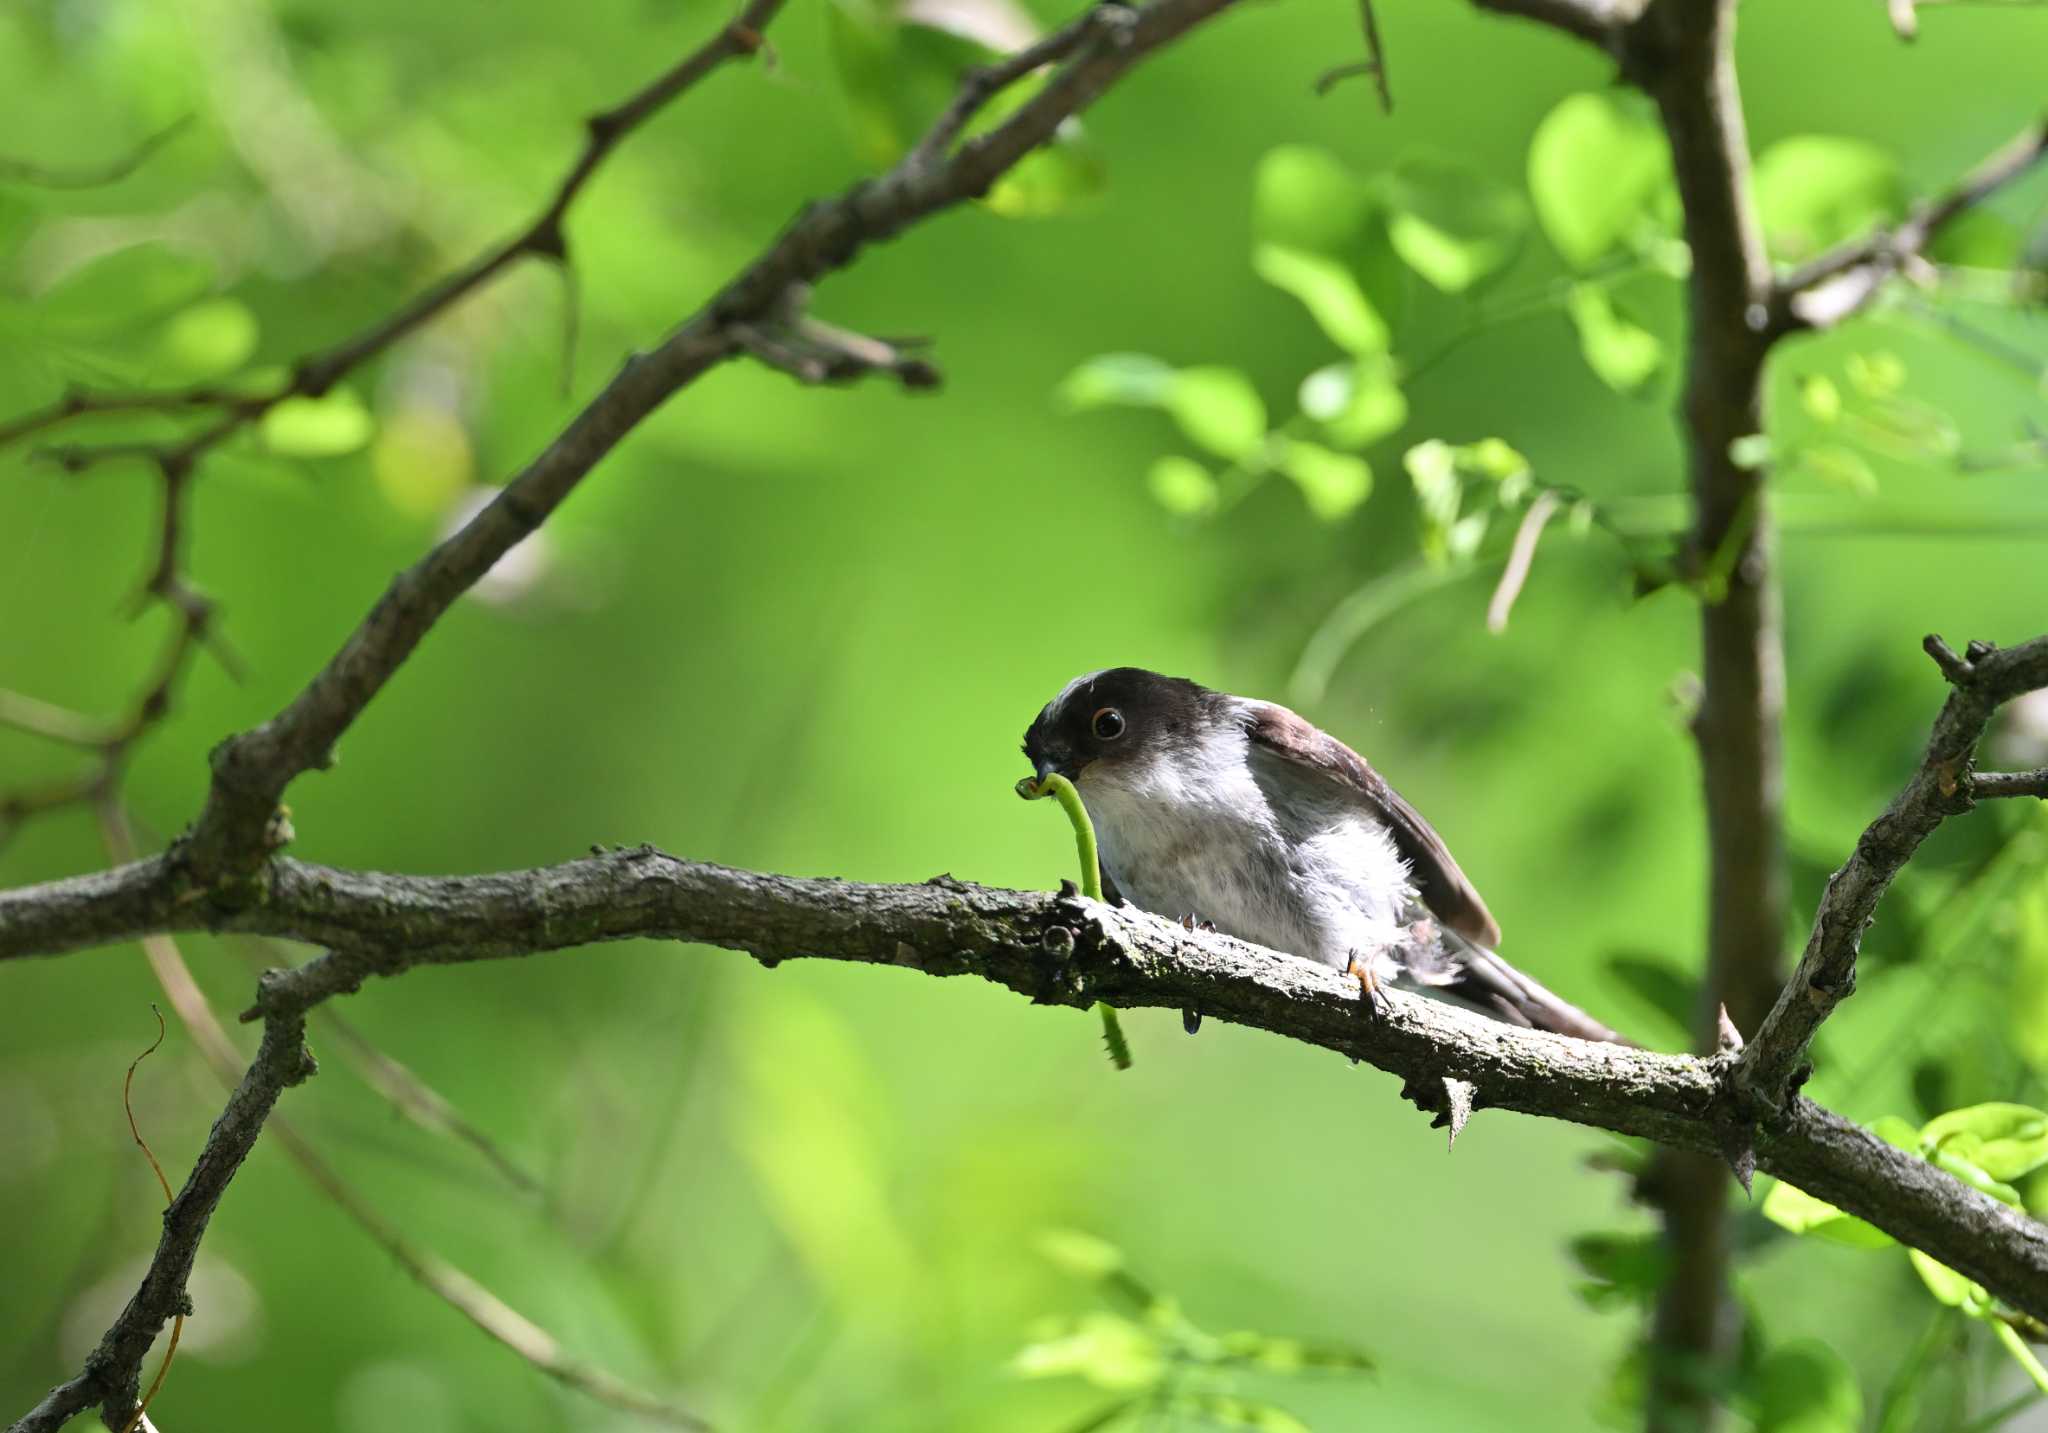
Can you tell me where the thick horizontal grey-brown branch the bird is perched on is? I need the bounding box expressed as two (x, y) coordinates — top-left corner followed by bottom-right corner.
(0, 848), (2048, 1316)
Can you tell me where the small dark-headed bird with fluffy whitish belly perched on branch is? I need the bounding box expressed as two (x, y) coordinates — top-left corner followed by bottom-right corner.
(1024, 667), (1620, 1042)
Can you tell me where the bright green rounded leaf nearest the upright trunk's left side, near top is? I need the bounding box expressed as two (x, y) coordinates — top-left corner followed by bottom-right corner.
(1528, 90), (1671, 268)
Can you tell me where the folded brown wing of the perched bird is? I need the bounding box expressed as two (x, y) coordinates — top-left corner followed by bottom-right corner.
(1245, 702), (1501, 950)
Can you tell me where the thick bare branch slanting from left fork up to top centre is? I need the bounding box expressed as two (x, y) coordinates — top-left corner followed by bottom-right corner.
(180, 0), (1233, 880)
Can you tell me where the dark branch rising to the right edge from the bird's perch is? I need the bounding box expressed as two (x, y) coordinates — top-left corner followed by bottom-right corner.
(1735, 637), (2048, 1110)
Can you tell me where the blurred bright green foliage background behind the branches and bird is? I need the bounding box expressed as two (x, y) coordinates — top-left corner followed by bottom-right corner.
(0, 0), (2048, 1433)
